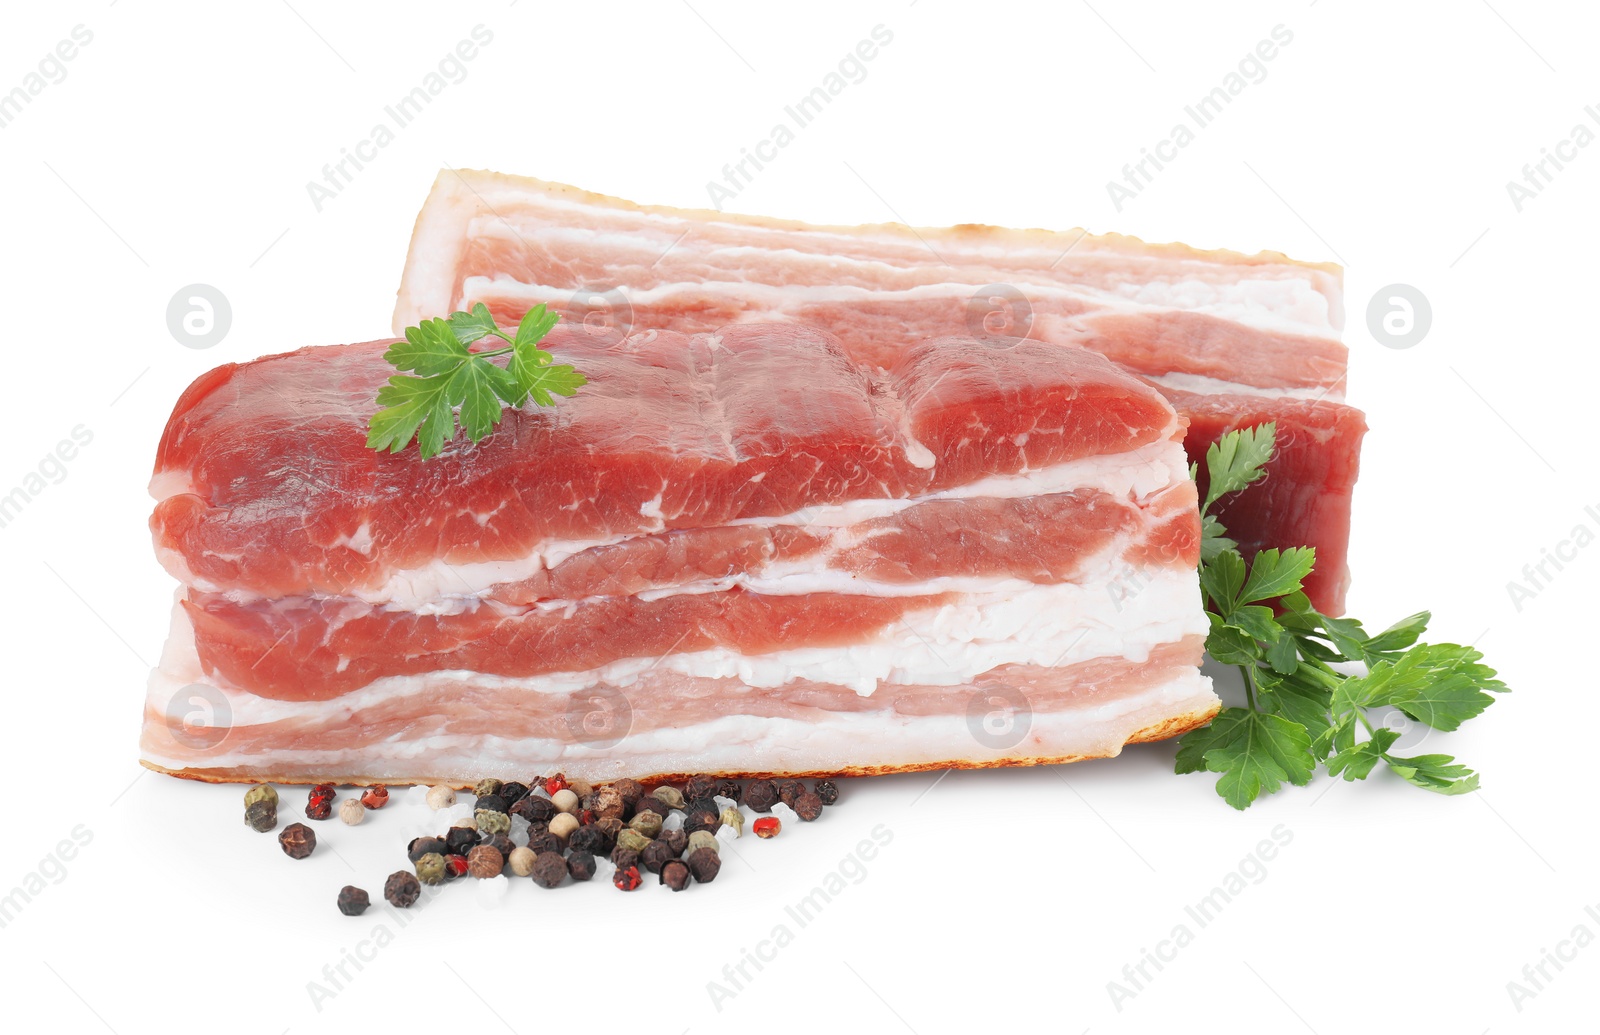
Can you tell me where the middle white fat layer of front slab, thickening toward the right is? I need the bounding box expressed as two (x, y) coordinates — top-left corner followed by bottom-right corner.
(150, 558), (1206, 723)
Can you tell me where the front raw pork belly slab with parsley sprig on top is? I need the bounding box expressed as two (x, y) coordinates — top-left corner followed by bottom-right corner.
(142, 323), (1218, 784)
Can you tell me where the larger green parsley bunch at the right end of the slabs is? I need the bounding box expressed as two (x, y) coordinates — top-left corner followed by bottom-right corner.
(1176, 424), (1507, 809)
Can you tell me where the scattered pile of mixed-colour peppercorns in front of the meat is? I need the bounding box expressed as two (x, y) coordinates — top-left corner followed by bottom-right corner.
(245, 773), (838, 917)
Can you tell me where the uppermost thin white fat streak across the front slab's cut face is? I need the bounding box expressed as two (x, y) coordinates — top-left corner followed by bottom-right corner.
(291, 426), (1189, 614)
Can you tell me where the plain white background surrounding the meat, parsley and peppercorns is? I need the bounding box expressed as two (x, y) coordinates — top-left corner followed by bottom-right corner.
(0, 0), (1600, 1035)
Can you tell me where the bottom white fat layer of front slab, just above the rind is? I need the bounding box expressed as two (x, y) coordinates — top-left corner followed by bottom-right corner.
(142, 670), (1218, 784)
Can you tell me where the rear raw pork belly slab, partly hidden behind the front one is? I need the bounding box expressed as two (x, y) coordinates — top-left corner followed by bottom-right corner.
(395, 171), (1366, 614)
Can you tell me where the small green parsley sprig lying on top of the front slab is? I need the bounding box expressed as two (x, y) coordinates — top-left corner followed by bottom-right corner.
(366, 302), (587, 459)
